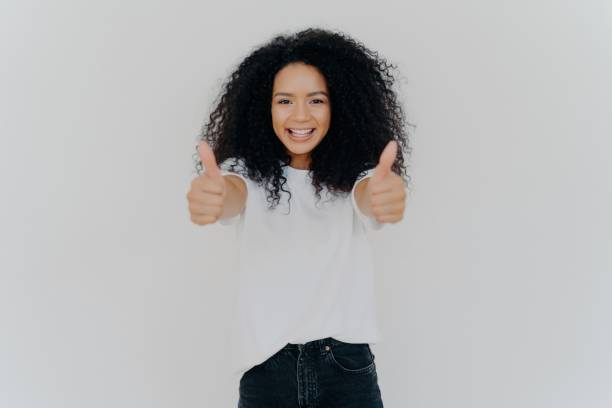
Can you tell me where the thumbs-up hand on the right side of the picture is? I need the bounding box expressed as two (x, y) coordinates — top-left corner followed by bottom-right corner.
(364, 140), (406, 223)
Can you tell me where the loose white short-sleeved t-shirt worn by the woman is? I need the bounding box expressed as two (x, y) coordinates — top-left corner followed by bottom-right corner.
(218, 158), (384, 377)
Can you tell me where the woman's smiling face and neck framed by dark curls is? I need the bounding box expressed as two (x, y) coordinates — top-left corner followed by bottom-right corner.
(272, 62), (331, 169)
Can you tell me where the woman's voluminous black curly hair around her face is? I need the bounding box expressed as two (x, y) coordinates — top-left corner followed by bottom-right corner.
(193, 28), (411, 210)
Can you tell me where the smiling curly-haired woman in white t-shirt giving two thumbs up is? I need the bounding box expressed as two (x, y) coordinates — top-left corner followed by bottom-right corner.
(187, 28), (409, 408)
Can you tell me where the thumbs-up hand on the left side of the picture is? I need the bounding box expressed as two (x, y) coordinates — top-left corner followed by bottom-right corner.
(187, 142), (227, 225)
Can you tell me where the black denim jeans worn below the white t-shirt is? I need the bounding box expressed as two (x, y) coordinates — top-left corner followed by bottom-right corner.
(238, 337), (383, 408)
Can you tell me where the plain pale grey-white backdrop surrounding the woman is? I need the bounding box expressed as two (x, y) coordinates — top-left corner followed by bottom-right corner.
(0, 0), (612, 408)
